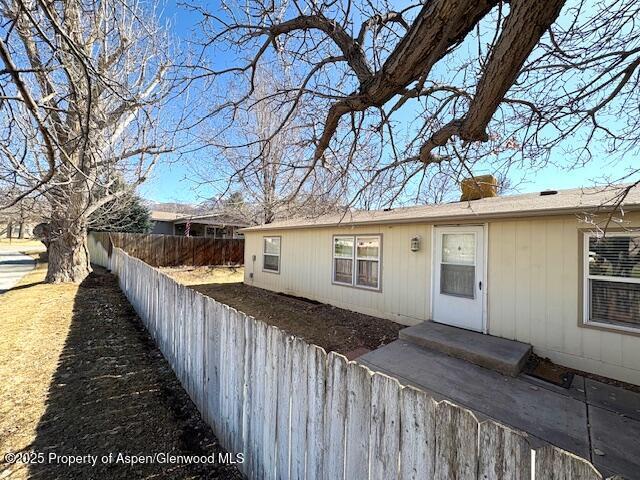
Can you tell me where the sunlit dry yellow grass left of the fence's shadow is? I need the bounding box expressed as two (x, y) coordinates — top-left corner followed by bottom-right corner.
(0, 264), (79, 478)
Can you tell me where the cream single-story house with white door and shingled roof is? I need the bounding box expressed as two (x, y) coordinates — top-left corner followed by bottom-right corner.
(243, 187), (640, 384)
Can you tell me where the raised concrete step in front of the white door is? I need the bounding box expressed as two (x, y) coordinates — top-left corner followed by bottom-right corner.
(400, 322), (531, 377)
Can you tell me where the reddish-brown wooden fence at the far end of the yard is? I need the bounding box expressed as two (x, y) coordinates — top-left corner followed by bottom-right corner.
(89, 232), (244, 267)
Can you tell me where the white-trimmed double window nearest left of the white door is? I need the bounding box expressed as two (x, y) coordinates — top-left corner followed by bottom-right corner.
(333, 235), (381, 290)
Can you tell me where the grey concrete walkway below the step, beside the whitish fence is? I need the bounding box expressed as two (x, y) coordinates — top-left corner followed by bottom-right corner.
(358, 340), (640, 479)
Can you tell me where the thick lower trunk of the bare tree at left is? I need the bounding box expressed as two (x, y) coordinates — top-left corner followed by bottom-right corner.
(46, 218), (91, 283)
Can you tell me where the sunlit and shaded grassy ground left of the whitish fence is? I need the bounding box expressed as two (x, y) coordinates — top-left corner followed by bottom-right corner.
(0, 264), (241, 479)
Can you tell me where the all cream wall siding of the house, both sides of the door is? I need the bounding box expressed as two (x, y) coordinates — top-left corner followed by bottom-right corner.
(245, 212), (640, 384)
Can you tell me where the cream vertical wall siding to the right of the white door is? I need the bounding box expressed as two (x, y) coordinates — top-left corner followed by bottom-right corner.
(488, 212), (640, 384)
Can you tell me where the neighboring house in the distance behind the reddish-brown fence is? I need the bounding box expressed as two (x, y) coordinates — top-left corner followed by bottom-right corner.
(151, 211), (248, 238)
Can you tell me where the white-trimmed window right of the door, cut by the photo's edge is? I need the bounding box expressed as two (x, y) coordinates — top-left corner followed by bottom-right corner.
(584, 232), (640, 330)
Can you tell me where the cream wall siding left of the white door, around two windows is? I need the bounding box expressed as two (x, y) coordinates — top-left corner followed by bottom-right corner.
(245, 224), (431, 325)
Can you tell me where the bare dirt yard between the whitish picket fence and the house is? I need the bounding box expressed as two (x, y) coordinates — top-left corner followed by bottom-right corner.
(163, 267), (404, 358)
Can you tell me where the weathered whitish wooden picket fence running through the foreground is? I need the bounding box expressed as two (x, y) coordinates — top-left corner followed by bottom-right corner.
(91, 242), (602, 480)
